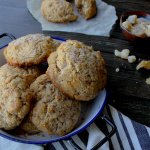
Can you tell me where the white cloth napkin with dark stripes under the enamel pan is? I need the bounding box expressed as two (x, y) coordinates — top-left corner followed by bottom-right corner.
(0, 105), (150, 150)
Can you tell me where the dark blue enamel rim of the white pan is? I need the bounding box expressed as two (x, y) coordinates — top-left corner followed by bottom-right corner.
(0, 36), (109, 145)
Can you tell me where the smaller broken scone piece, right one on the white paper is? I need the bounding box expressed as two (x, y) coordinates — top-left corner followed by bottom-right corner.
(75, 0), (97, 20)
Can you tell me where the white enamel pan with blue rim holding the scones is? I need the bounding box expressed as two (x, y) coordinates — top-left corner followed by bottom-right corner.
(0, 37), (109, 144)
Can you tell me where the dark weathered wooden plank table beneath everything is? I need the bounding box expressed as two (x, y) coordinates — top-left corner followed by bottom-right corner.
(0, 0), (150, 126)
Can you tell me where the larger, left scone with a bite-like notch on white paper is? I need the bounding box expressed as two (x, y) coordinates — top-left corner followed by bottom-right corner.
(41, 0), (78, 23)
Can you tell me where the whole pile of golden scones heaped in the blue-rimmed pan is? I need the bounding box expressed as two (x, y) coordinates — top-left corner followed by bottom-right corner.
(0, 34), (107, 135)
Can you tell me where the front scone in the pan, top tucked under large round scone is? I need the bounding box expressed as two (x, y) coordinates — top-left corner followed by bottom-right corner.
(30, 74), (81, 135)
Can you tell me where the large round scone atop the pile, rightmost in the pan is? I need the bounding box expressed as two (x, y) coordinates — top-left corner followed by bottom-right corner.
(46, 40), (107, 101)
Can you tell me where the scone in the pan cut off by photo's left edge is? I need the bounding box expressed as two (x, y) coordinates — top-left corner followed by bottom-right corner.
(0, 66), (32, 130)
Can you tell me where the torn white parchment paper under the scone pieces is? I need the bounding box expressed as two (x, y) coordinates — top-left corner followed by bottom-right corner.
(27, 0), (117, 36)
